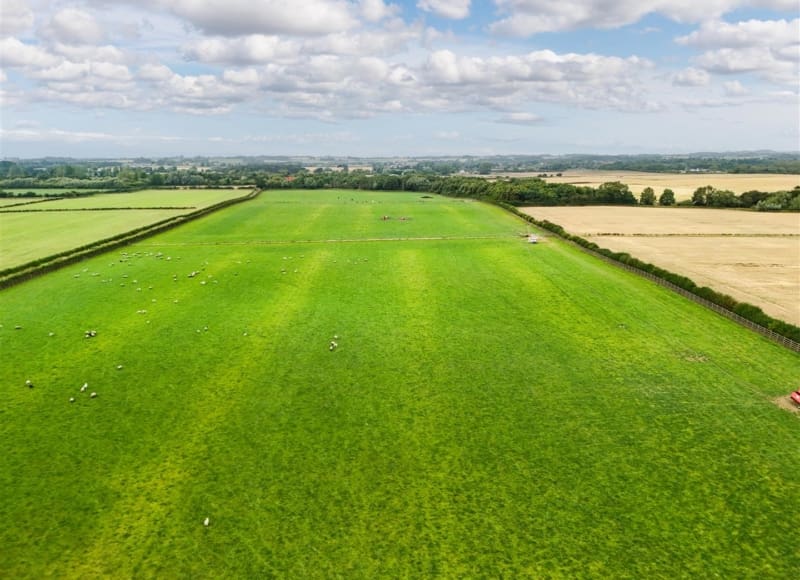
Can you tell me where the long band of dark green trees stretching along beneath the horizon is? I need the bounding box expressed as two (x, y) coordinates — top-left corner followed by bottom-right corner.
(0, 161), (800, 211)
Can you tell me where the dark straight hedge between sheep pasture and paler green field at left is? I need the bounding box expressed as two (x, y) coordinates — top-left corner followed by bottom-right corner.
(0, 189), (261, 289)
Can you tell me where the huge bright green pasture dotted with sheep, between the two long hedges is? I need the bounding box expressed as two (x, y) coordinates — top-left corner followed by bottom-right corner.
(0, 191), (800, 578)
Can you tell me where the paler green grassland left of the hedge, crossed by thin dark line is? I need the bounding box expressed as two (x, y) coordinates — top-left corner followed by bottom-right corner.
(0, 189), (247, 269)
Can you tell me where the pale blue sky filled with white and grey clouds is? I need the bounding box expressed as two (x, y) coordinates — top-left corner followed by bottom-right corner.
(0, 0), (800, 157)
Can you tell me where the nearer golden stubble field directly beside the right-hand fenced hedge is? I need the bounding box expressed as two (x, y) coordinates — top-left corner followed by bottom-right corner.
(521, 207), (800, 326)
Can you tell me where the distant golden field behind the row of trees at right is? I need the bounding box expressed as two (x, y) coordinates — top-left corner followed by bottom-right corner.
(496, 169), (800, 201)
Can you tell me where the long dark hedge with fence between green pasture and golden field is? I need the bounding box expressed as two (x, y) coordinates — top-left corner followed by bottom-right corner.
(498, 203), (800, 352)
